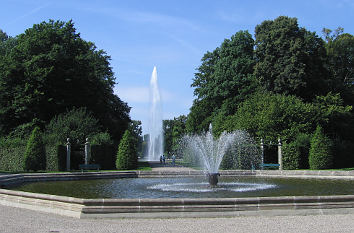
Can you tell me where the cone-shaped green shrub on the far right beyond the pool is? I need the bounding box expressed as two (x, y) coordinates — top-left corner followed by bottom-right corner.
(309, 126), (333, 169)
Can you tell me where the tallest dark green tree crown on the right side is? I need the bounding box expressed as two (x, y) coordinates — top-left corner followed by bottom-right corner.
(254, 16), (328, 101)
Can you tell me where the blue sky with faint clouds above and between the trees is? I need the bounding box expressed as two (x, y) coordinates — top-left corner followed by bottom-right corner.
(0, 0), (354, 132)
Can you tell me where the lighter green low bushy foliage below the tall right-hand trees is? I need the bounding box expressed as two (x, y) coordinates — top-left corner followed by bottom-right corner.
(213, 93), (351, 143)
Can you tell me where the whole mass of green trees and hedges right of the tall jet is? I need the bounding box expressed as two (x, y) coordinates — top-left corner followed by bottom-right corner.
(165, 16), (354, 169)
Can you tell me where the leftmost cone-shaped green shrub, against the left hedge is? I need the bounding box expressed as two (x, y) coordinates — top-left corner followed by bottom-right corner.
(23, 127), (46, 171)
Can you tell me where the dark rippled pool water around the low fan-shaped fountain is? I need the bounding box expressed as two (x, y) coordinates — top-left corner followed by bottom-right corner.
(12, 177), (354, 198)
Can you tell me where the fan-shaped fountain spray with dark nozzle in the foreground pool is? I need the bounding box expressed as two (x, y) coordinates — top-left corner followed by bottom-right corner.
(181, 124), (259, 187)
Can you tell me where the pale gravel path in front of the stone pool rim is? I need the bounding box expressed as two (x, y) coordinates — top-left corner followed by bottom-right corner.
(0, 205), (354, 233)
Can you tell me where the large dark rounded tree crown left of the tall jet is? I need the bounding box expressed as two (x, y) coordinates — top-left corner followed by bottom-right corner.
(0, 20), (130, 140)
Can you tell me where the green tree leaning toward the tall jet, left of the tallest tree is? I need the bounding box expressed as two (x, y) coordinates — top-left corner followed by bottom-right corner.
(188, 31), (256, 132)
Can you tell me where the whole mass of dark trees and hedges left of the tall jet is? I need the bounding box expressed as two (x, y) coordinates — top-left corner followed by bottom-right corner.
(0, 20), (141, 171)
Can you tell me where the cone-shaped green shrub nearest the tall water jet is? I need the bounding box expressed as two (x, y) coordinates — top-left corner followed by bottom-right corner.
(116, 130), (138, 170)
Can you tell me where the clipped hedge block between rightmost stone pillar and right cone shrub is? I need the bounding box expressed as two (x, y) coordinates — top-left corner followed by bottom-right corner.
(282, 142), (301, 170)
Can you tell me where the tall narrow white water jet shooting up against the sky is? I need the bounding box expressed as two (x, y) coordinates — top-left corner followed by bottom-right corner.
(148, 66), (163, 161)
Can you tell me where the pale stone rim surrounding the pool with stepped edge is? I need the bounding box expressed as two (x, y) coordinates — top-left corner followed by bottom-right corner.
(0, 170), (354, 218)
